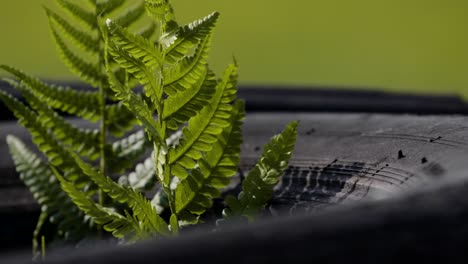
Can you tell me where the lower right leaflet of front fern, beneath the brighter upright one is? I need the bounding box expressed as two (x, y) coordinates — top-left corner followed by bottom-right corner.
(175, 101), (245, 220)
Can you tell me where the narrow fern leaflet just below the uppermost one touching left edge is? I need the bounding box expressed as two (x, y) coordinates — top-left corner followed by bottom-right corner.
(6, 79), (100, 160)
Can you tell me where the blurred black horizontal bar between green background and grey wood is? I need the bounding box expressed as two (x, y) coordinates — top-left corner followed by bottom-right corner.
(0, 82), (468, 120)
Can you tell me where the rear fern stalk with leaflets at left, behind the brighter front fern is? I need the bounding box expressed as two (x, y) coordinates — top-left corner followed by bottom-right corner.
(0, 0), (154, 252)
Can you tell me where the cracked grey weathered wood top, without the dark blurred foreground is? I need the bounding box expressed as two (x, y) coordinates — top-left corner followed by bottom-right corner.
(0, 113), (468, 212)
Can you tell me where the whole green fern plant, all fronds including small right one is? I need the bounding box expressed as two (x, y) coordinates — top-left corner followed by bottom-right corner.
(0, 0), (297, 250)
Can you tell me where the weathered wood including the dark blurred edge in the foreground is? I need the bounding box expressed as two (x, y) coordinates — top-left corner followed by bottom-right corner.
(1, 113), (468, 263)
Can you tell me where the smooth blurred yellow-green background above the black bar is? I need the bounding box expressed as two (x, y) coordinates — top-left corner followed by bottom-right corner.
(0, 0), (468, 96)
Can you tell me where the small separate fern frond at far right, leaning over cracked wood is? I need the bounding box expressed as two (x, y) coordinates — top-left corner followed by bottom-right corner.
(223, 121), (298, 219)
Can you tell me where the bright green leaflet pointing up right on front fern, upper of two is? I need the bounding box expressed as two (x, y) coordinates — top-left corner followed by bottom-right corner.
(169, 65), (237, 178)
